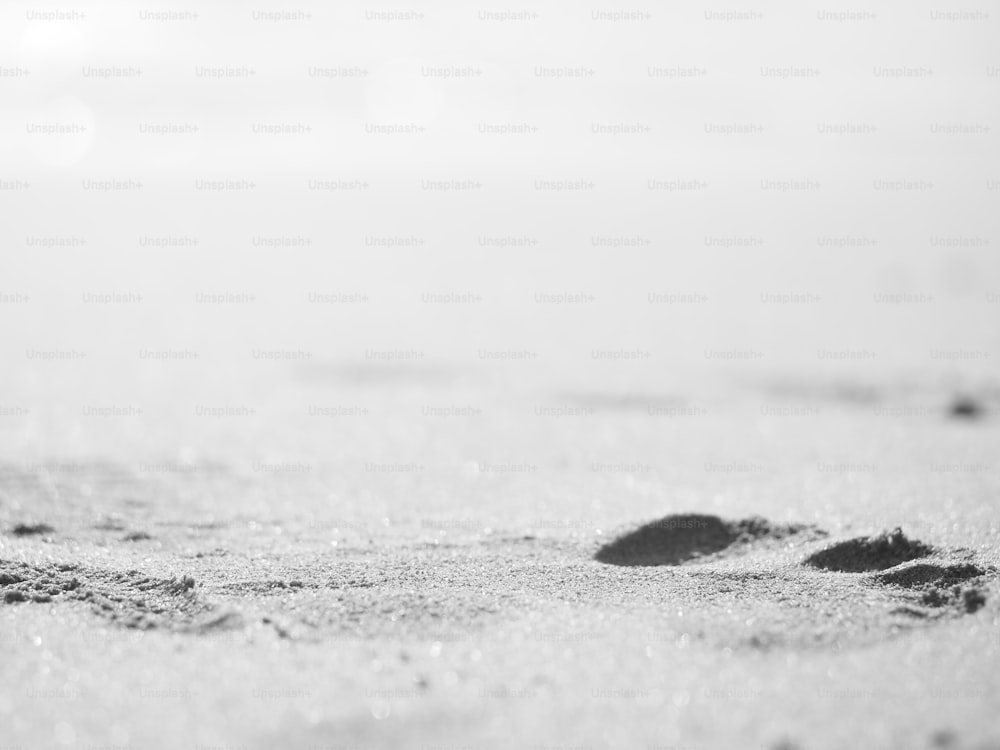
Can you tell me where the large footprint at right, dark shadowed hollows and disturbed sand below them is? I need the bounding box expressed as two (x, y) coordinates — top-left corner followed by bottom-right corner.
(594, 514), (997, 649)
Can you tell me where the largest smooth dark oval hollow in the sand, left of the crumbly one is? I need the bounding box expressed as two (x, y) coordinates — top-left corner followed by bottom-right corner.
(594, 513), (824, 565)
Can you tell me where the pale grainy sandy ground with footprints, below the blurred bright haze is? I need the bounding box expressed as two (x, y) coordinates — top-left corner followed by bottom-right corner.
(0, 374), (1000, 750)
